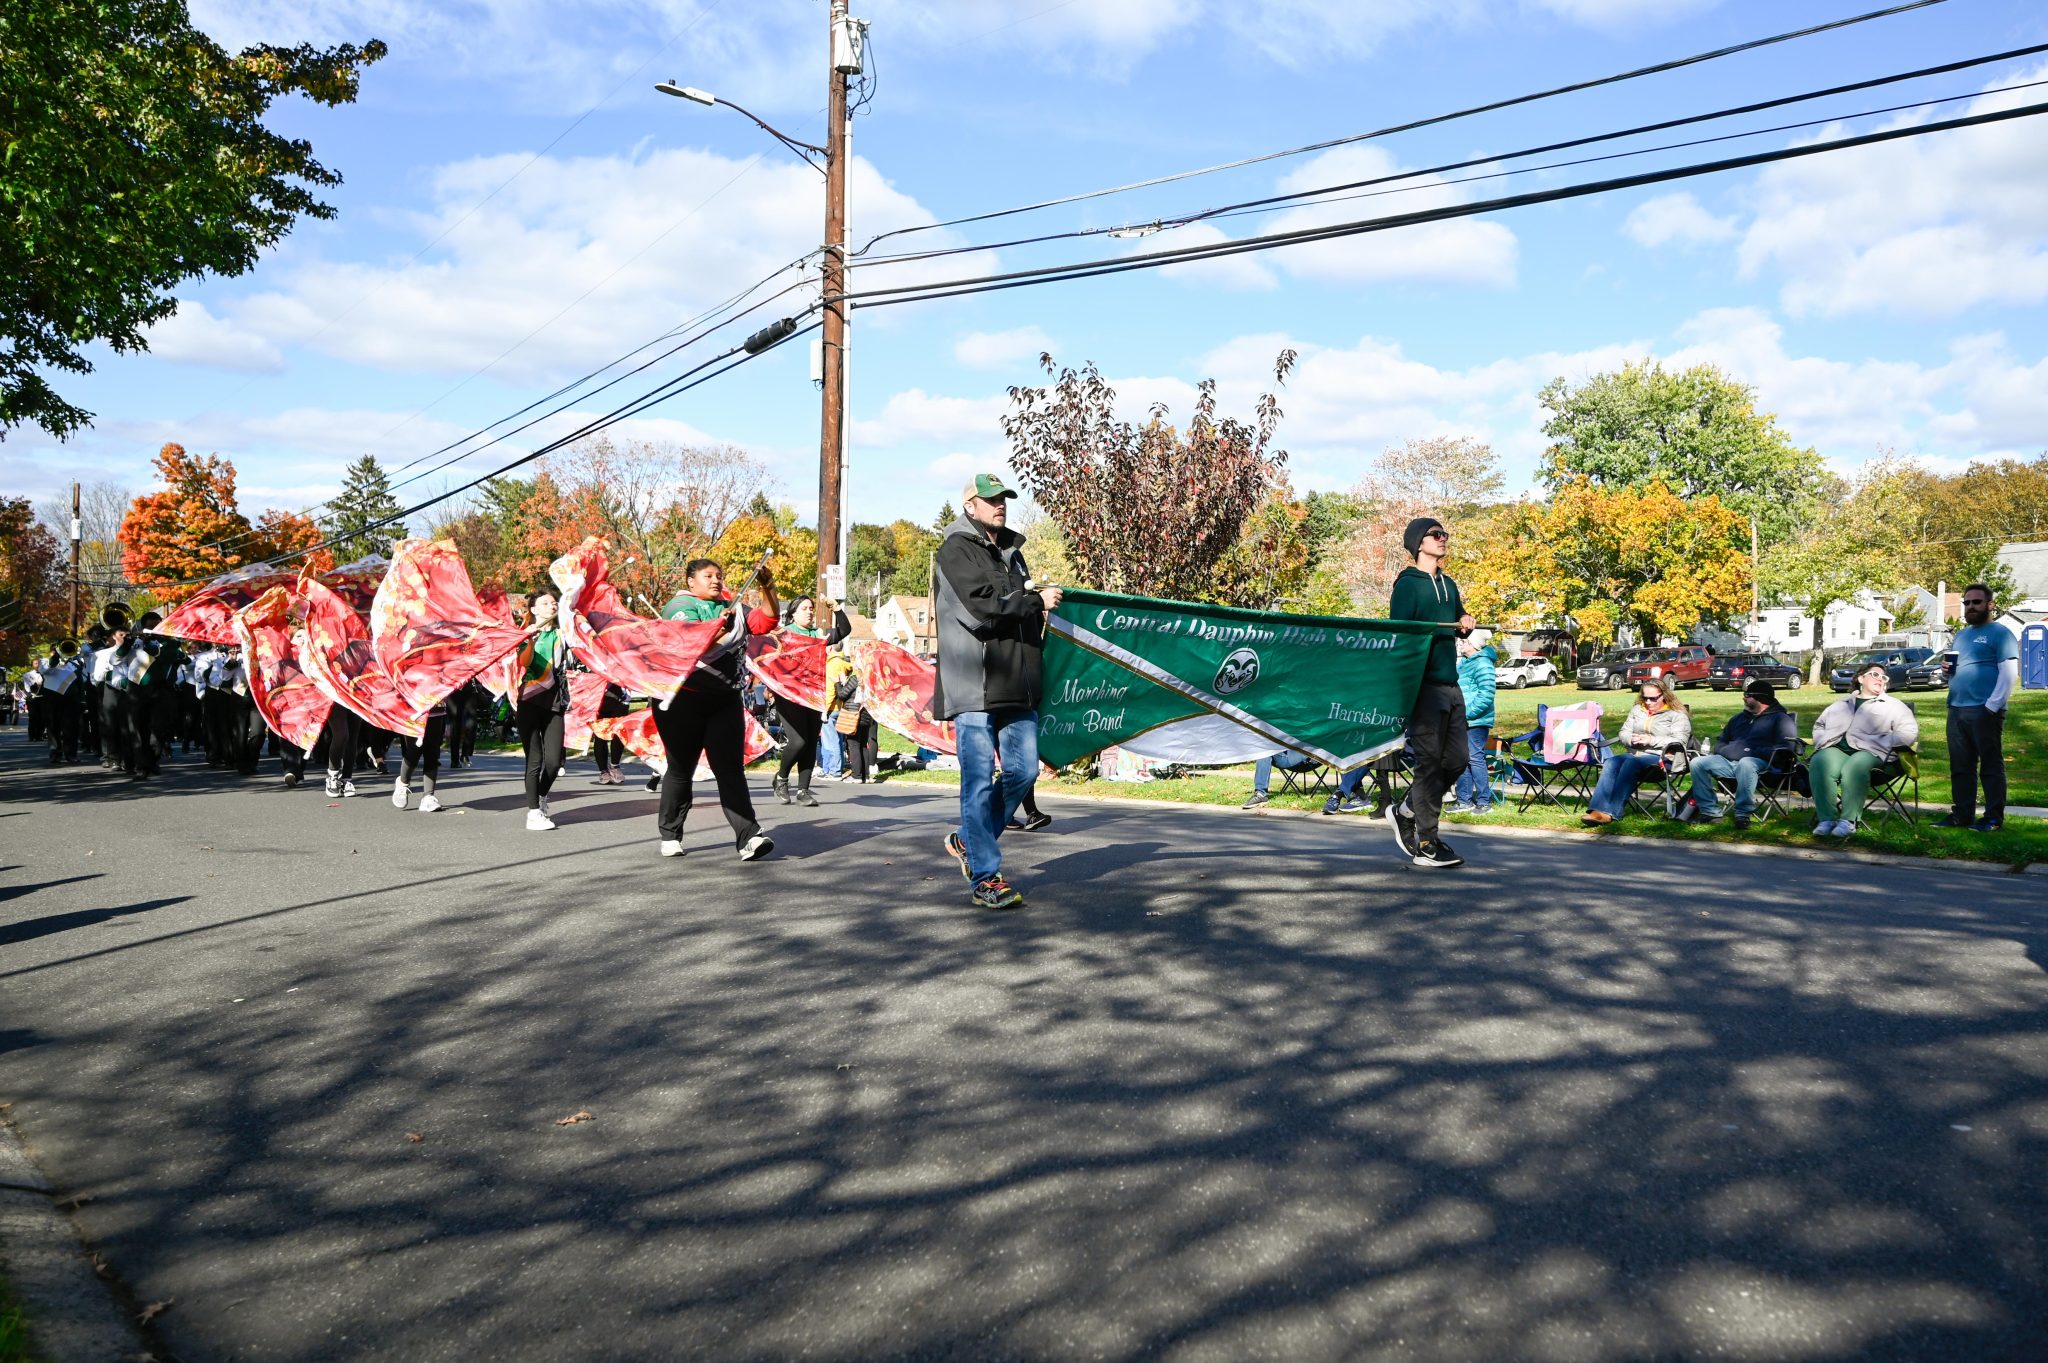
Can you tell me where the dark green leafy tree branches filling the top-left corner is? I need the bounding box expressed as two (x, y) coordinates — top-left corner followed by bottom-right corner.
(0, 0), (385, 438)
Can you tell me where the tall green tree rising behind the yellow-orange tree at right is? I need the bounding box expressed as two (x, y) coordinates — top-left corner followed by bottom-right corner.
(1538, 360), (1827, 546)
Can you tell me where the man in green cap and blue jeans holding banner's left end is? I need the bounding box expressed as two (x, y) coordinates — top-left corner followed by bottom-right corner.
(932, 473), (1061, 909)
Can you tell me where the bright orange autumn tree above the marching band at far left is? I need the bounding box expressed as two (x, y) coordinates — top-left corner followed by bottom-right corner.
(121, 444), (262, 602)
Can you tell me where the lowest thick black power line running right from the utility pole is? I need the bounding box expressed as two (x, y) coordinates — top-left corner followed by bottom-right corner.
(827, 102), (2048, 307)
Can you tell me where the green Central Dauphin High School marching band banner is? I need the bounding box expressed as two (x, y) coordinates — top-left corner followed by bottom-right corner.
(1038, 589), (1440, 772)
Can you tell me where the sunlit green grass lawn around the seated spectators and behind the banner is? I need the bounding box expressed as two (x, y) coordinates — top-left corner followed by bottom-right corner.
(883, 686), (2048, 866)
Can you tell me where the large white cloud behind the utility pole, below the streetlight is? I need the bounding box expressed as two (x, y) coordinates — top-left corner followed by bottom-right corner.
(225, 149), (993, 385)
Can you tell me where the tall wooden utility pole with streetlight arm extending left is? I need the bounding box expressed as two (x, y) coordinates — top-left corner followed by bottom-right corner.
(655, 0), (868, 591)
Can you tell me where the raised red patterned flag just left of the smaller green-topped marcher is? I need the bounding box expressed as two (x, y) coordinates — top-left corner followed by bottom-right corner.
(371, 540), (528, 714)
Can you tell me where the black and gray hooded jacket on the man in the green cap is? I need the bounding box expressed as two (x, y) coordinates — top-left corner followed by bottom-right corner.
(932, 516), (1044, 720)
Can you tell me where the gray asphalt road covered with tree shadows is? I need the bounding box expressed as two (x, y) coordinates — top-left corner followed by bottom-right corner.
(0, 729), (2048, 1363)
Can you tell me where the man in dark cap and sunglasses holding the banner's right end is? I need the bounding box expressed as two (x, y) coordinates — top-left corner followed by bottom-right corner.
(1386, 516), (1475, 868)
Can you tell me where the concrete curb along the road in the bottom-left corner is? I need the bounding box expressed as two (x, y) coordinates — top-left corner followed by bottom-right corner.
(0, 1119), (154, 1363)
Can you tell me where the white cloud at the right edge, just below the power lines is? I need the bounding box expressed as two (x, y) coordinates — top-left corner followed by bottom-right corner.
(1741, 68), (2048, 317)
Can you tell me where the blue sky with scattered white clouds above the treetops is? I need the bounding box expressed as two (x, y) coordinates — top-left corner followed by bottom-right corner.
(0, 0), (2048, 540)
